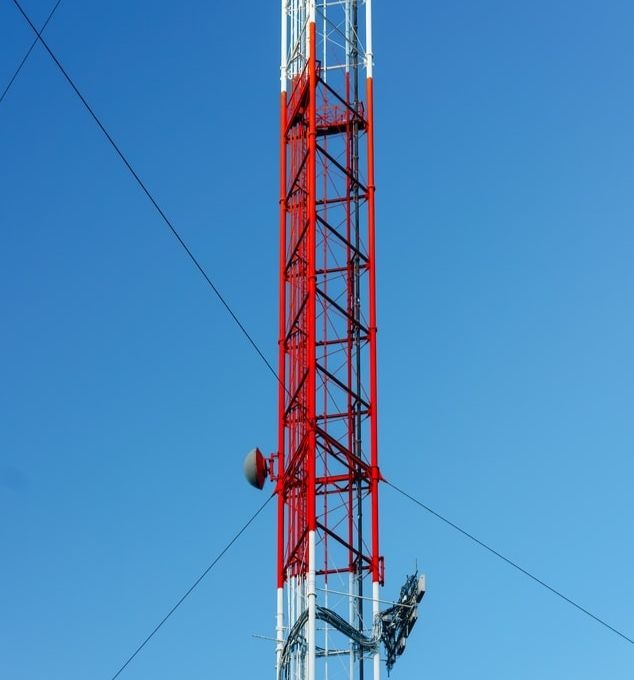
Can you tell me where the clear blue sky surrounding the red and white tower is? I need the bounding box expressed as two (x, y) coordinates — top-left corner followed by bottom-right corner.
(0, 0), (634, 680)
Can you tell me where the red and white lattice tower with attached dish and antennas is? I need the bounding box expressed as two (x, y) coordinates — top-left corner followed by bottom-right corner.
(245, 0), (424, 680)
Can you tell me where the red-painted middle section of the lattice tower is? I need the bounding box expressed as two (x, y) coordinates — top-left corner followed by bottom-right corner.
(273, 13), (383, 608)
